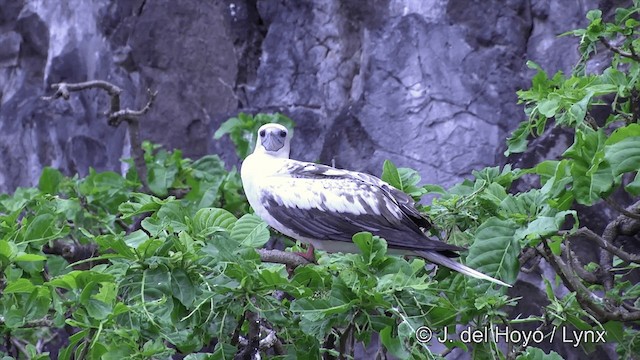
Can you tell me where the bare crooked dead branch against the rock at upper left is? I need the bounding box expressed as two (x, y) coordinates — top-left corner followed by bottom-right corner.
(42, 80), (158, 192)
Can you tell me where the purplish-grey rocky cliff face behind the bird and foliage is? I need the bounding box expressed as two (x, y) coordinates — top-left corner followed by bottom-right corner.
(0, 0), (619, 358)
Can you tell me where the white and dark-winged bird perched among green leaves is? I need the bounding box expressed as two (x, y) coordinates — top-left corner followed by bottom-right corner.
(240, 123), (511, 287)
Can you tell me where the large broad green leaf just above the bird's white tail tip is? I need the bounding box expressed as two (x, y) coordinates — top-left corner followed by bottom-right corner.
(466, 217), (520, 283)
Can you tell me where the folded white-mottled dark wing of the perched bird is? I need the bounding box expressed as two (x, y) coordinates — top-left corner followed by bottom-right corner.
(261, 160), (463, 256)
